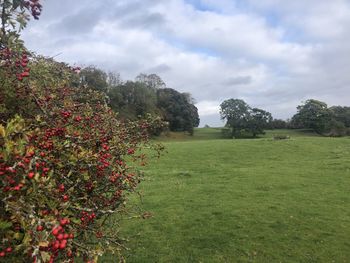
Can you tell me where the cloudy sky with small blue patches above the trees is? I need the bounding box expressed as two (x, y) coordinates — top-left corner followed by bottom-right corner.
(23, 0), (350, 126)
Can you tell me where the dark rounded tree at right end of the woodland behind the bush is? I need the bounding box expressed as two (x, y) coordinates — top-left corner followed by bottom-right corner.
(157, 88), (199, 134)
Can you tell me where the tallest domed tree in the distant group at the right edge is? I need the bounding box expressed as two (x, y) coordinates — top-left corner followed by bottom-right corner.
(292, 99), (332, 134)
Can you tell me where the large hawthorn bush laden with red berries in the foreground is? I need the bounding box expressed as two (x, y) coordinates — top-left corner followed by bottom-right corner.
(0, 0), (163, 262)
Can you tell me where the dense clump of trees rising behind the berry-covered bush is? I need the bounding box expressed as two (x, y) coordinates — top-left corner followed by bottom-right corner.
(80, 66), (200, 135)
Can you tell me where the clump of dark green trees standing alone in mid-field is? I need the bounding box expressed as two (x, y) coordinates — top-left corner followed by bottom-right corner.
(220, 99), (272, 137)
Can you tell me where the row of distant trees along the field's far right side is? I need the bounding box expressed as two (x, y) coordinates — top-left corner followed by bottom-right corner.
(220, 99), (350, 138)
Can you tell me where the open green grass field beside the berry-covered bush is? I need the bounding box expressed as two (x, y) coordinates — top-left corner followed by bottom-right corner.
(102, 129), (350, 262)
